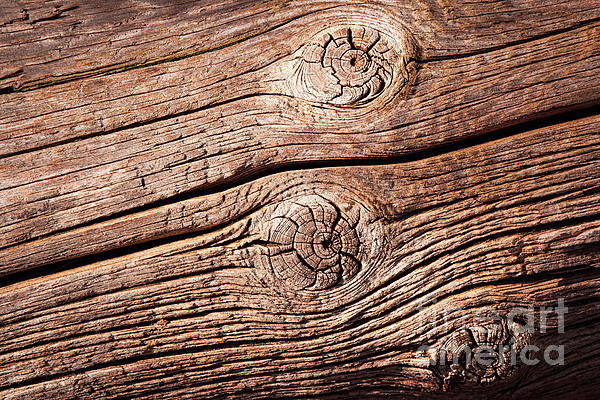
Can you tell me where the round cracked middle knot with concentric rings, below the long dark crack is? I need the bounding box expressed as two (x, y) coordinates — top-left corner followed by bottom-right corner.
(269, 196), (361, 290)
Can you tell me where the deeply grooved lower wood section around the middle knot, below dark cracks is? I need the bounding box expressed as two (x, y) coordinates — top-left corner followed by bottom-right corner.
(0, 117), (600, 399)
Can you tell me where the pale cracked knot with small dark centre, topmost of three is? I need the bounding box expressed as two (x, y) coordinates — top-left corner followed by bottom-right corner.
(295, 26), (404, 106)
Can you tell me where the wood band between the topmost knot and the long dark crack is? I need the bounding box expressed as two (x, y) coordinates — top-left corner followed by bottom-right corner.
(0, 24), (600, 256)
